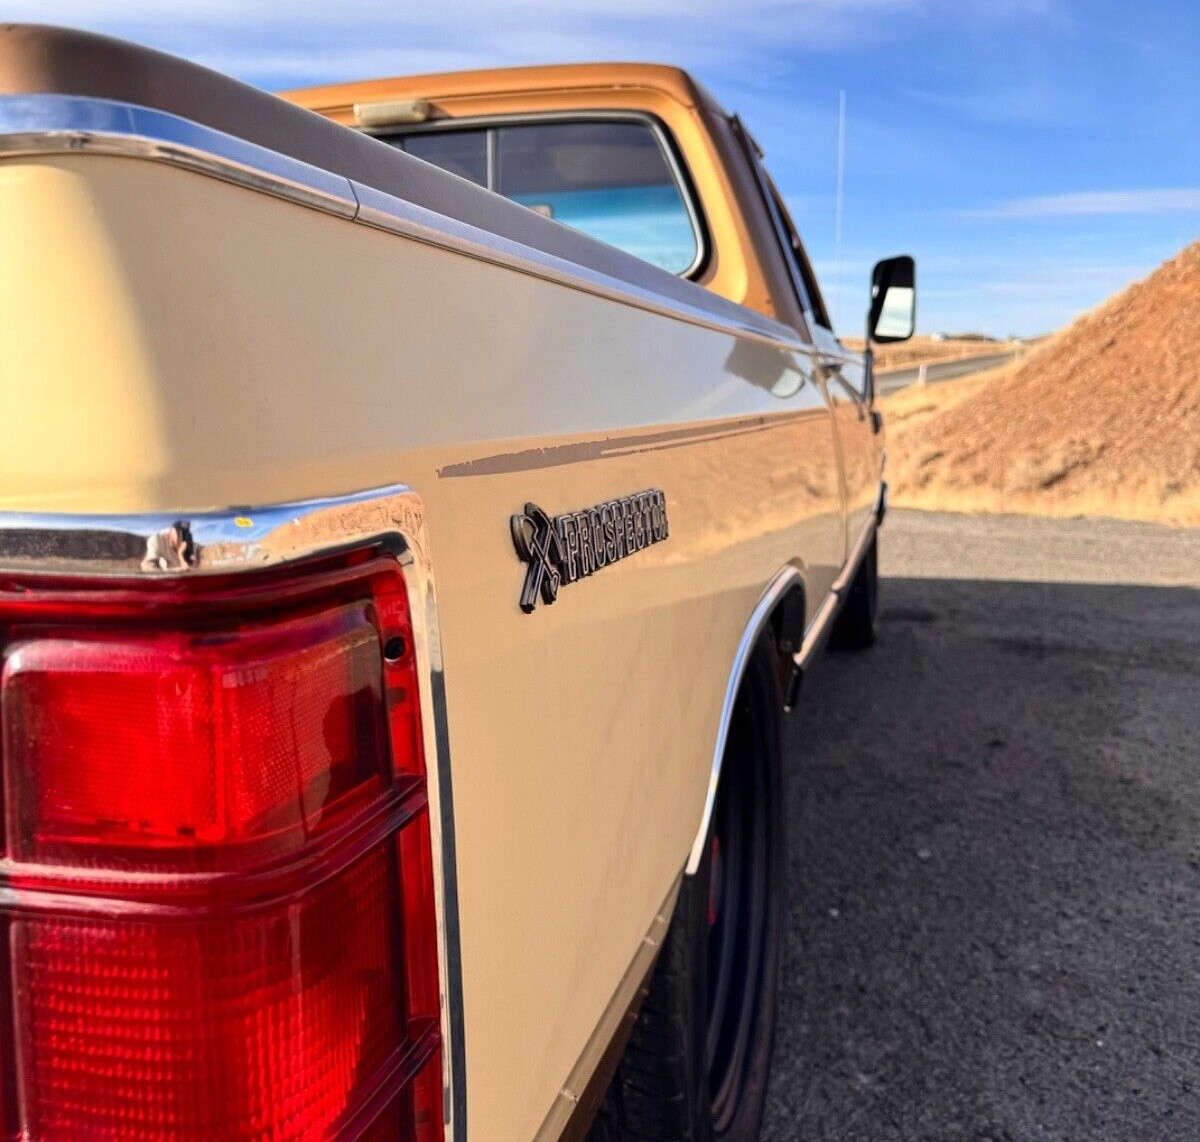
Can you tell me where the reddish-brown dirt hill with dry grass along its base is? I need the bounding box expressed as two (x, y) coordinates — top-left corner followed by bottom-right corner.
(884, 242), (1200, 524)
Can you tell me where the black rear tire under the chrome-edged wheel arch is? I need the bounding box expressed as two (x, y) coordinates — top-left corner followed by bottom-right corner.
(588, 637), (785, 1142)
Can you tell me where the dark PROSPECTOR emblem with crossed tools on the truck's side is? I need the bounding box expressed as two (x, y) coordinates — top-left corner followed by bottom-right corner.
(510, 488), (670, 614)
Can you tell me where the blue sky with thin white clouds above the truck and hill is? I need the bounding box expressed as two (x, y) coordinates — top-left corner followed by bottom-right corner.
(16, 0), (1200, 335)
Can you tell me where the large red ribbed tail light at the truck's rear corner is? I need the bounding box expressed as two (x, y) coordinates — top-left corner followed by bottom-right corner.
(0, 555), (442, 1142)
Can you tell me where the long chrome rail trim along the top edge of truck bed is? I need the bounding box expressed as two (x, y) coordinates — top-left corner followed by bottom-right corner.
(0, 95), (810, 353)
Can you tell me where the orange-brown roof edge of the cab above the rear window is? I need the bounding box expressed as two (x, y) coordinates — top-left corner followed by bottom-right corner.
(280, 64), (725, 115)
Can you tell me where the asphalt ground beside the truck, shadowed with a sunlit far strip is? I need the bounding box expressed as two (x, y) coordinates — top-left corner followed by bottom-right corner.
(762, 511), (1200, 1142)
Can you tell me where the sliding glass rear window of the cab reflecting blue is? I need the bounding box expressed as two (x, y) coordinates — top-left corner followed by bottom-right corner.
(386, 120), (702, 275)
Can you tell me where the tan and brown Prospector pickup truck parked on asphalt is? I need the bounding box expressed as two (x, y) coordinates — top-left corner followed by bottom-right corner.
(0, 25), (914, 1142)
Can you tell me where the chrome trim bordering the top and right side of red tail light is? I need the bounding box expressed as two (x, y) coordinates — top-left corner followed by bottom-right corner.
(0, 485), (467, 1142)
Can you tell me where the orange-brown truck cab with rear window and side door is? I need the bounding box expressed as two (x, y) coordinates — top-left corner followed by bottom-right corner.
(283, 64), (882, 588)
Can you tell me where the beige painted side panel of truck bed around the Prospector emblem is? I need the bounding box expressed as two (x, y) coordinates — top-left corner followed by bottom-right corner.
(0, 131), (873, 1142)
